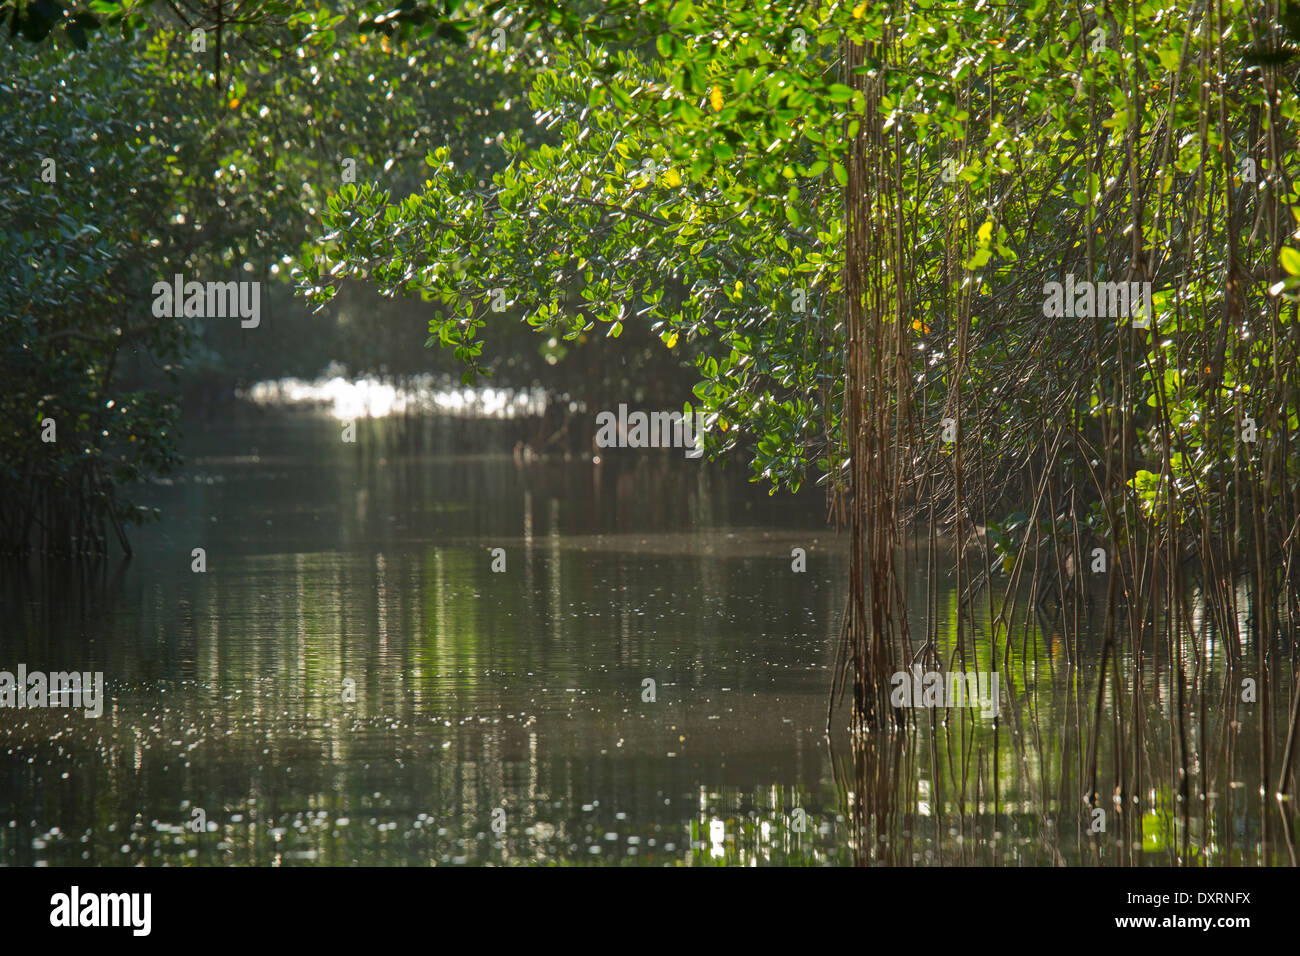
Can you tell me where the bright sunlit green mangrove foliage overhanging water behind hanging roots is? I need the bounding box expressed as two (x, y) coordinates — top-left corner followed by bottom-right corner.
(306, 0), (1297, 561)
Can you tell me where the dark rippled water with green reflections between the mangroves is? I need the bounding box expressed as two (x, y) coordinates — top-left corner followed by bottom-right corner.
(0, 410), (1294, 865)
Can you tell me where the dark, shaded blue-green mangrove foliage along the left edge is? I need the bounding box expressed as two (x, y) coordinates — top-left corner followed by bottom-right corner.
(0, 33), (183, 550)
